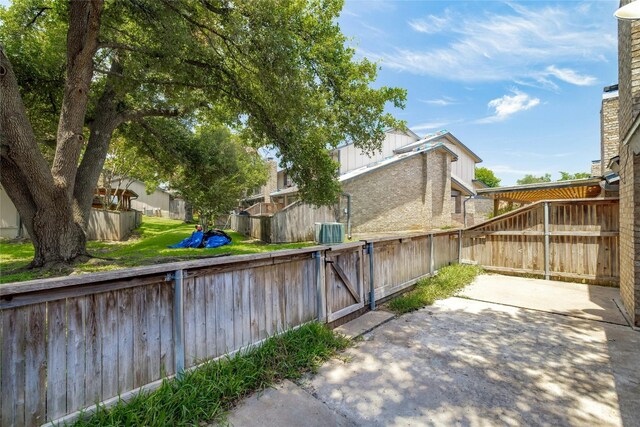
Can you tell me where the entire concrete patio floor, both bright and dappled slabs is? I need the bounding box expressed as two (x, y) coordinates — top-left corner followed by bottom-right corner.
(229, 276), (640, 427)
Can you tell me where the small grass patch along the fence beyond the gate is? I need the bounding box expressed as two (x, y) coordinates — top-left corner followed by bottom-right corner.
(389, 264), (482, 313)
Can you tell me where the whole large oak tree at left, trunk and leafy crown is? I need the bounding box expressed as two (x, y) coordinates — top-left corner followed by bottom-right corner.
(0, 0), (405, 267)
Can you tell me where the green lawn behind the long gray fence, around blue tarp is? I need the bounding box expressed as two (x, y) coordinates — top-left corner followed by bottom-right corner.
(0, 216), (312, 283)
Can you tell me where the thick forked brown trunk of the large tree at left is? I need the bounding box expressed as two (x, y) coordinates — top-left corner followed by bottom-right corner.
(0, 0), (103, 268)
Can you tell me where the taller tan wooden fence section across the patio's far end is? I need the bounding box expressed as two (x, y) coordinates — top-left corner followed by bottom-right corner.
(462, 199), (620, 285)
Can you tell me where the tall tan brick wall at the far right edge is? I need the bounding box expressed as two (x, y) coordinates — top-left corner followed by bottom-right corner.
(618, 0), (640, 325)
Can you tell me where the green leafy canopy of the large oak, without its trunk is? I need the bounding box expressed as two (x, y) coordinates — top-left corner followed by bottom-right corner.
(0, 0), (406, 204)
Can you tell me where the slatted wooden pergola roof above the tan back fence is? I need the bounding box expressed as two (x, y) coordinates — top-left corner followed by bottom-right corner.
(477, 178), (604, 215)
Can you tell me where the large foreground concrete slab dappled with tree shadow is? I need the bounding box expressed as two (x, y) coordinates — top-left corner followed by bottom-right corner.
(308, 298), (640, 426)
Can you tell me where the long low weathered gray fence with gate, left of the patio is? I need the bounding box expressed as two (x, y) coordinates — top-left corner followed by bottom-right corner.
(0, 231), (459, 426)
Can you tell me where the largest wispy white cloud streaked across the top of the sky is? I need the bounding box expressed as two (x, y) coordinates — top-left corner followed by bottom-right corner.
(366, 2), (616, 84)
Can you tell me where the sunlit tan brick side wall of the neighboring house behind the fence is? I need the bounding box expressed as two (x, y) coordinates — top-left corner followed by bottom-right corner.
(341, 150), (451, 233)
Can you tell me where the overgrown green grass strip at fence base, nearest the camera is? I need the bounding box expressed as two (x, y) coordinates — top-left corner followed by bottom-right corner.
(74, 323), (349, 426)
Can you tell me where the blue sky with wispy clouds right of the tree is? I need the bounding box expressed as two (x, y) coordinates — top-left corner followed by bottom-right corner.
(339, 0), (618, 185)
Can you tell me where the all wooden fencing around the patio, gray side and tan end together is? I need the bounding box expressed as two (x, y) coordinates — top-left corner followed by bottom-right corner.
(0, 205), (619, 426)
